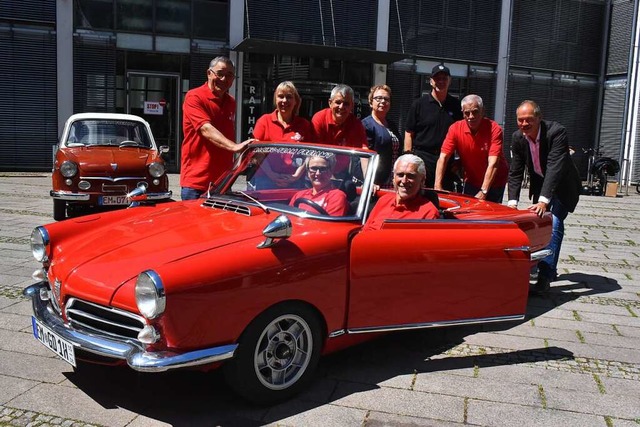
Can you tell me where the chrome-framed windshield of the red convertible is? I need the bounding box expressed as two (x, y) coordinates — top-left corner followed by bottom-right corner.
(208, 144), (377, 218)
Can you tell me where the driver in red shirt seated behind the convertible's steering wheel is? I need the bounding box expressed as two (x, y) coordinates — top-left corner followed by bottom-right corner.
(289, 153), (349, 216)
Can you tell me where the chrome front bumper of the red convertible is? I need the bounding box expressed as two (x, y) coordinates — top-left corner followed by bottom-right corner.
(23, 282), (238, 372)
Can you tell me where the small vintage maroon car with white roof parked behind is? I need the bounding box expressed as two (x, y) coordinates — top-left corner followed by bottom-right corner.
(51, 113), (171, 221)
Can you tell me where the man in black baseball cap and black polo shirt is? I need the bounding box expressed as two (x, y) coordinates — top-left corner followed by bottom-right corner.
(404, 64), (462, 190)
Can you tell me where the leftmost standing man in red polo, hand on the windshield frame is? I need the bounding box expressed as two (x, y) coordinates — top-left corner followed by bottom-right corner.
(180, 56), (250, 200)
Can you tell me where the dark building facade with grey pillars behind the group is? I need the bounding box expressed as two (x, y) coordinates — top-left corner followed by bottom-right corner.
(0, 0), (640, 187)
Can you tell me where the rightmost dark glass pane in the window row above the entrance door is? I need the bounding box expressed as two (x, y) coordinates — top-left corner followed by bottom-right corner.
(193, 0), (229, 40)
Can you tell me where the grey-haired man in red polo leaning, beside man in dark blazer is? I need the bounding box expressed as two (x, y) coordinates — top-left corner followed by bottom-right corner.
(434, 95), (509, 203)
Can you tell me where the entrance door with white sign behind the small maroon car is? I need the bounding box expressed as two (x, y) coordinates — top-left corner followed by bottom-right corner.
(127, 71), (181, 172)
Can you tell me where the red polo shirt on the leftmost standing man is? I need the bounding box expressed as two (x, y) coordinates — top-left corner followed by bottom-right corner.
(180, 83), (236, 191)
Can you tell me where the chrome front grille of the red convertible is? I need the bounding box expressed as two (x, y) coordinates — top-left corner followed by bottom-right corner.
(65, 298), (145, 339)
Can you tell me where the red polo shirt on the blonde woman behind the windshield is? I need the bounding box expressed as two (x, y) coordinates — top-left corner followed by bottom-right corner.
(253, 111), (315, 176)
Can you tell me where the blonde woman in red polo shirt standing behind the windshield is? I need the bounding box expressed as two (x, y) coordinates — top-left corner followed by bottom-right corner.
(252, 81), (315, 190)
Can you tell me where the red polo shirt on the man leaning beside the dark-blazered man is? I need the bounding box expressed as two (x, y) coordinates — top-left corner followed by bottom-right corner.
(440, 117), (509, 188)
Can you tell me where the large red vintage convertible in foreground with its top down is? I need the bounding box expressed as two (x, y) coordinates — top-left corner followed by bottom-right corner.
(25, 143), (551, 403)
